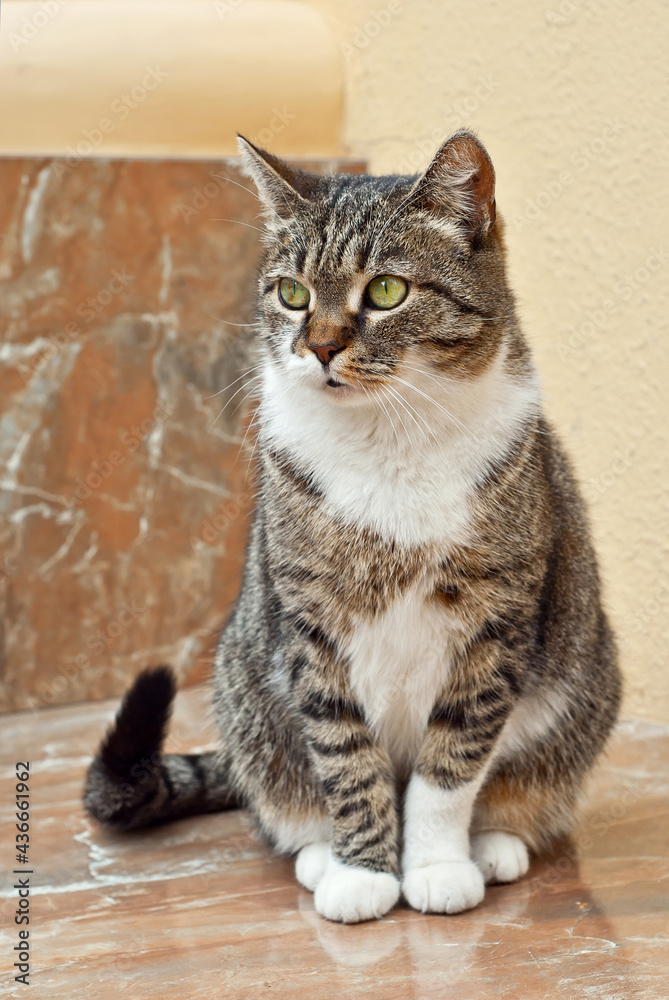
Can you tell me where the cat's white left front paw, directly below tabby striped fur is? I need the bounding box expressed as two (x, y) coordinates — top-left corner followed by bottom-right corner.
(314, 855), (400, 924)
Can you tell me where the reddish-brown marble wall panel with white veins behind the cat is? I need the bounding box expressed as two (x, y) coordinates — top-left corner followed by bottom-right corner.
(0, 159), (359, 710)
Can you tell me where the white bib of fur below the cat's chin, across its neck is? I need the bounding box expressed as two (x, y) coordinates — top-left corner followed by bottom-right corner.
(261, 351), (538, 550)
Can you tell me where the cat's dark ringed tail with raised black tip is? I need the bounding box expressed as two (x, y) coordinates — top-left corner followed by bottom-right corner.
(84, 667), (239, 830)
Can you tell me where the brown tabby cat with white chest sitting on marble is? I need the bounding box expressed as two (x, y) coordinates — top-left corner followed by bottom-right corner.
(85, 130), (621, 923)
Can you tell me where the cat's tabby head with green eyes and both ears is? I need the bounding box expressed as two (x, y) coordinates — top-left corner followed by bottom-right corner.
(239, 131), (513, 404)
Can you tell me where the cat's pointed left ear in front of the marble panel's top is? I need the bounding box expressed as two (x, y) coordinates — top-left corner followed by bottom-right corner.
(237, 135), (318, 218)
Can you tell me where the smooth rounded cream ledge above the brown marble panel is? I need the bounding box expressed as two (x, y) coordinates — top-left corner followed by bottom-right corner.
(0, 0), (343, 157)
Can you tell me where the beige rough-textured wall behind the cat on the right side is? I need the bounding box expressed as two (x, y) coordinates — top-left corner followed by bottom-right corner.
(312, 0), (669, 721)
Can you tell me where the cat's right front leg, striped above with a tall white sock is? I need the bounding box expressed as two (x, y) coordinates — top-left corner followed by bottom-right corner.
(402, 641), (527, 913)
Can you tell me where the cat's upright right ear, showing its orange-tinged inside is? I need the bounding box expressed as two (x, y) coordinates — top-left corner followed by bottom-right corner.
(414, 129), (495, 239)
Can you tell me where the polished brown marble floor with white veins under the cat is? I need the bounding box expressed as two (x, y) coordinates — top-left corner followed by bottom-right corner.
(0, 688), (669, 1000)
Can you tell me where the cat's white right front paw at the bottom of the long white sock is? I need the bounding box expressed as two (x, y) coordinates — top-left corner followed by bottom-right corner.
(402, 858), (485, 913)
